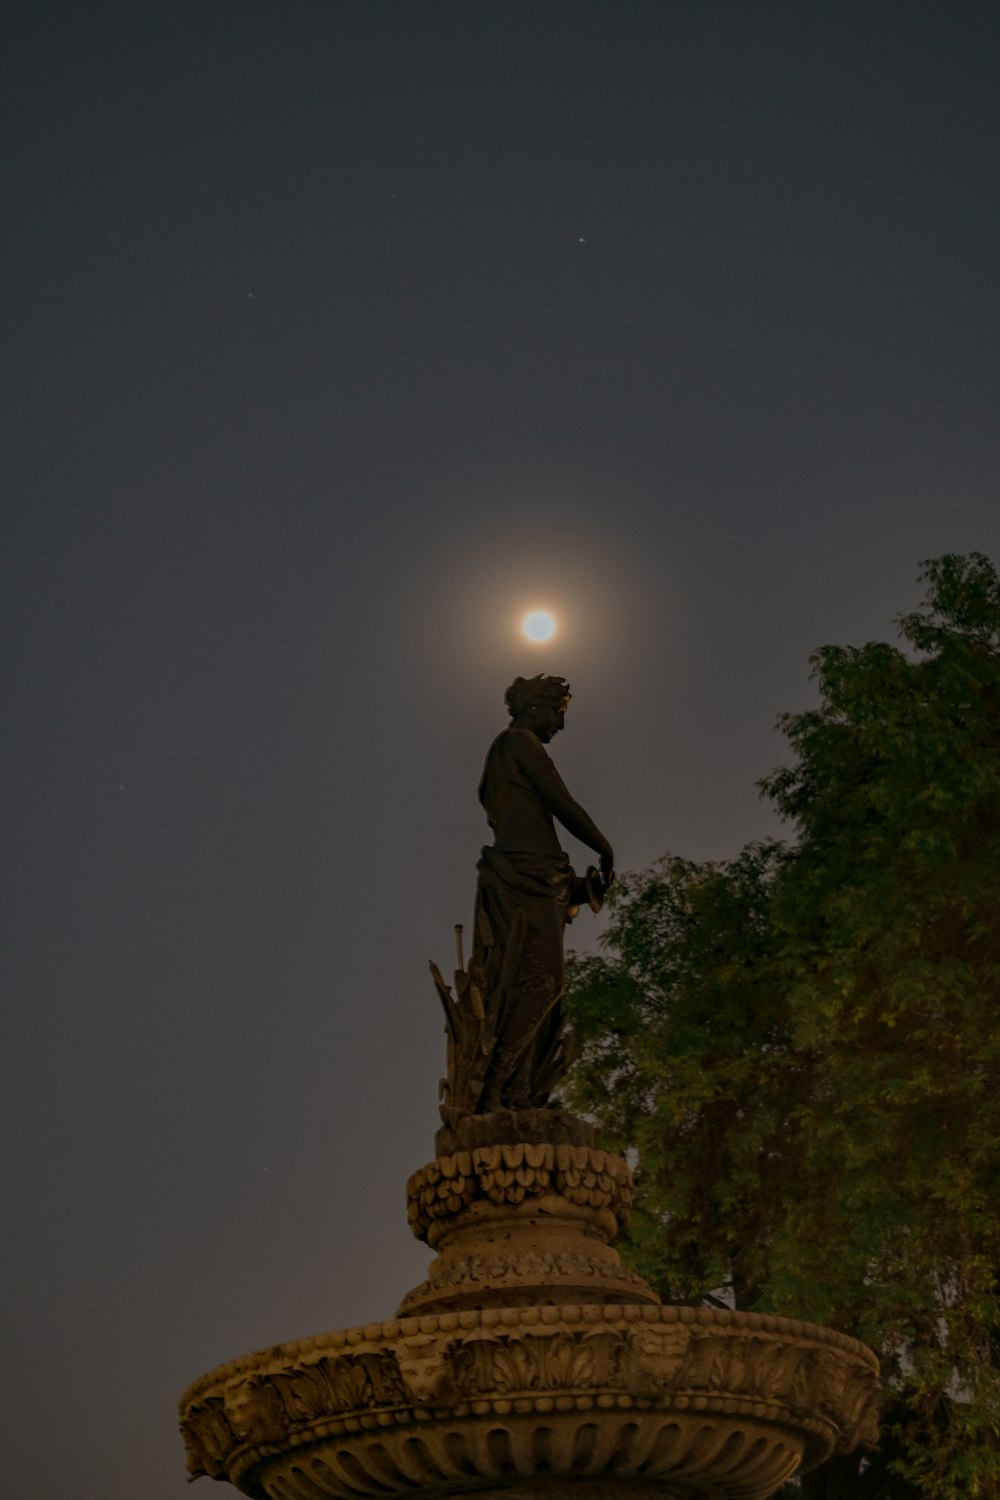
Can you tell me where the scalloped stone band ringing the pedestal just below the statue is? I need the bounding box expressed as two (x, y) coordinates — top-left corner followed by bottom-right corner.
(406, 1142), (633, 1248)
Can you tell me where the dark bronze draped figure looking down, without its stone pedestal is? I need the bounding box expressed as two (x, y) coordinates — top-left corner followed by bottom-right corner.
(430, 675), (615, 1125)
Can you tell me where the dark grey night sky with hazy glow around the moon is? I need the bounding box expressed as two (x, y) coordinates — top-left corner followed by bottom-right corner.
(0, 0), (1000, 1500)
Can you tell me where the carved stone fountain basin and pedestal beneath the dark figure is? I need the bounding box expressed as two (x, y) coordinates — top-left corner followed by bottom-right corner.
(181, 1112), (877, 1500)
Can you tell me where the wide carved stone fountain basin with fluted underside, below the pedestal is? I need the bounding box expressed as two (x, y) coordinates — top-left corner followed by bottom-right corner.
(181, 1304), (877, 1500)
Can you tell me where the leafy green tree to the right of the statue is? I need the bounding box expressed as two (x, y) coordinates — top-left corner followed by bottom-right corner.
(570, 554), (1000, 1500)
